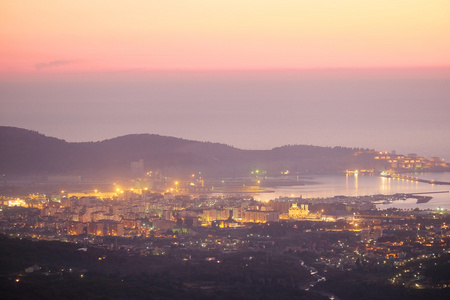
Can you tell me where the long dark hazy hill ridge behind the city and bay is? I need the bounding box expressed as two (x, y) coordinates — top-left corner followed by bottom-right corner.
(0, 126), (383, 176)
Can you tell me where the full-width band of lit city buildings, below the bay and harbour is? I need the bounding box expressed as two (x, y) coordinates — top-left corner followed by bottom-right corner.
(0, 182), (450, 288)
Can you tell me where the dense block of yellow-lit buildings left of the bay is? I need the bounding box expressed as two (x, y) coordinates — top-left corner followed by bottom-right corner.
(0, 188), (320, 237)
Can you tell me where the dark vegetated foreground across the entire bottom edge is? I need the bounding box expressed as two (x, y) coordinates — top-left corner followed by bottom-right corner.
(0, 233), (450, 300)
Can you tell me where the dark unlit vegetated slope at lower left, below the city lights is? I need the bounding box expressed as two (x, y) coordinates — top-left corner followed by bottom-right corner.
(0, 236), (326, 300)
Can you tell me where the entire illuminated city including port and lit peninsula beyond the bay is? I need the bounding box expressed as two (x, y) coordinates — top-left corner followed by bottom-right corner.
(0, 142), (450, 299)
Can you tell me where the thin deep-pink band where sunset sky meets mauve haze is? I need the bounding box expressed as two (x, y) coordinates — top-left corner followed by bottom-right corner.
(0, 65), (450, 83)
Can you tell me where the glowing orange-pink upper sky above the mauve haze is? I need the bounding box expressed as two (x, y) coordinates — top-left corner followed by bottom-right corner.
(0, 0), (450, 74)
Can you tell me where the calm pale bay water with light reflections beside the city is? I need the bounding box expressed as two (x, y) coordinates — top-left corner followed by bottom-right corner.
(255, 172), (450, 210)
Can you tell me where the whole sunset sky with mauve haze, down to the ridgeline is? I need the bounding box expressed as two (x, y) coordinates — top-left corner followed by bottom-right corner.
(0, 0), (450, 159)
